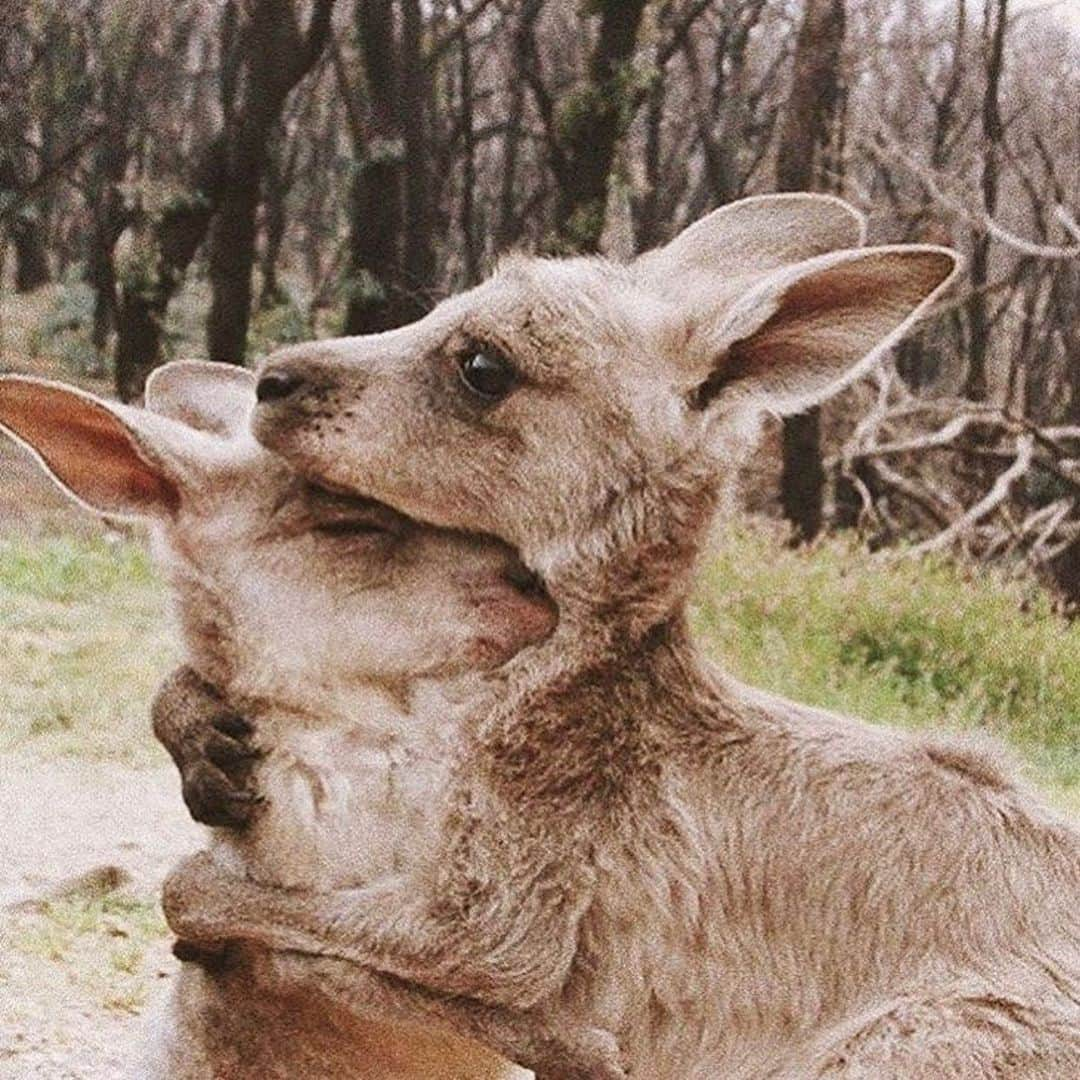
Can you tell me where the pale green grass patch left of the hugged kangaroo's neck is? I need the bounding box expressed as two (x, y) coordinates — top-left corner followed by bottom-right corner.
(0, 537), (178, 765)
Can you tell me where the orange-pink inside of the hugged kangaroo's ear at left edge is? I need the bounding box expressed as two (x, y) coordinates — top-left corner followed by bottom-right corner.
(0, 381), (180, 513)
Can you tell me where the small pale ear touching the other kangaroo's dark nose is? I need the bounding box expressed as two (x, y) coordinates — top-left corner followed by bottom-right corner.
(146, 360), (255, 438)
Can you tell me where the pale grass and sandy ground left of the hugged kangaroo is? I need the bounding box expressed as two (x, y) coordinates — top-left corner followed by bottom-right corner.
(0, 527), (183, 1080)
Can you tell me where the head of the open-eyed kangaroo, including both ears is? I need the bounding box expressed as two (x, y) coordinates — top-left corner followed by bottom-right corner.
(254, 195), (956, 618)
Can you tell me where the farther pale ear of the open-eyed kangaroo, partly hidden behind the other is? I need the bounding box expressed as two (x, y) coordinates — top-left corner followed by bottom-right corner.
(635, 192), (866, 296)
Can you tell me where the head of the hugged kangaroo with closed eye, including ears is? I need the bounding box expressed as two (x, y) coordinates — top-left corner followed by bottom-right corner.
(0, 363), (553, 707)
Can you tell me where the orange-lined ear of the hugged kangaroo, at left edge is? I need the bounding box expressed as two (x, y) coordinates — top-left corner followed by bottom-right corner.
(0, 376), (205, 517)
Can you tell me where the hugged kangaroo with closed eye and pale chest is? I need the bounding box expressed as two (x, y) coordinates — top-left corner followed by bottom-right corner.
(0, 364), (574, 1080)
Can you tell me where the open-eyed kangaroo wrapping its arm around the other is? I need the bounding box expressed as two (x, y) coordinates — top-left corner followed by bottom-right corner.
(165, 195), (1080, 1080)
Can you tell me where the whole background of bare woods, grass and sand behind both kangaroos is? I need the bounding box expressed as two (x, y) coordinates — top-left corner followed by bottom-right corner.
(0, 0), (1080, 1078)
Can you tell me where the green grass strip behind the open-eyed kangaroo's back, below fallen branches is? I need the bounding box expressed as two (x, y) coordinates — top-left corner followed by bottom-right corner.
(694, 529), (1080, 809)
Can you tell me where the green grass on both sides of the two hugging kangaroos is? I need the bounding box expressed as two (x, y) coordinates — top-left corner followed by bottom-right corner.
(0, 520), (1080, 808)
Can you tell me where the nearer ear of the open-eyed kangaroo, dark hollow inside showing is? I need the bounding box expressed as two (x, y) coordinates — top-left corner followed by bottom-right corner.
(685, 245), (959, 414)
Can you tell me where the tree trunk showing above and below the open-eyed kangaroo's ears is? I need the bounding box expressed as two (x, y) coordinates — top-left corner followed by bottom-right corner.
(777, 0), (845, 542)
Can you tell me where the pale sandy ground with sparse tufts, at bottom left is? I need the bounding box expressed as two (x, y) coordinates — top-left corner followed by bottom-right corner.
(0, 755), (200, 1080)
